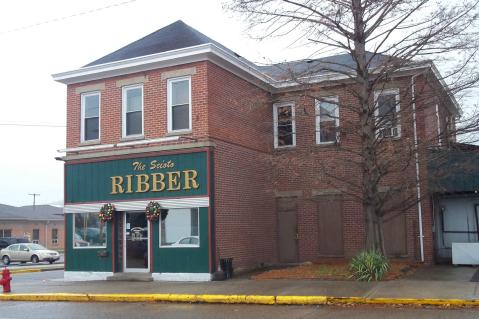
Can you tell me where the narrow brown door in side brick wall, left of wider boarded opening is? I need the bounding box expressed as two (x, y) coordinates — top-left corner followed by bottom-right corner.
(276, 197), (298, 263)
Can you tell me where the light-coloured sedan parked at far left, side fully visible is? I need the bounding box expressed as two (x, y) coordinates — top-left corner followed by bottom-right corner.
(0, 243), (60, 265)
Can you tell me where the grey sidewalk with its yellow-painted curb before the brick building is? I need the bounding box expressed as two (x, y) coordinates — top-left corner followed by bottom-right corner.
(0, 269), (479, 306)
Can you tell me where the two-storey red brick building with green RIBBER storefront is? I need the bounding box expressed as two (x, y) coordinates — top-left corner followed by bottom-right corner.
(53, 21), (457, 280)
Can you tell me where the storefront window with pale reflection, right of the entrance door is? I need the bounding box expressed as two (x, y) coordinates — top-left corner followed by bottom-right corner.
(160, 208), (200, 248)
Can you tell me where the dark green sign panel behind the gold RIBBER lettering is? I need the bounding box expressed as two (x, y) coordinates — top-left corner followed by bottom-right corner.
(65, 152), (208, 203)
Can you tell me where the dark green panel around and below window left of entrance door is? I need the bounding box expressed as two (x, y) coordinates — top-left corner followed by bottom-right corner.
(65, 214), (112, 272)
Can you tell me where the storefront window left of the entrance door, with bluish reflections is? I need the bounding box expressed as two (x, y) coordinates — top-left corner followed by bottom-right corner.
(73, 213), (106, 248)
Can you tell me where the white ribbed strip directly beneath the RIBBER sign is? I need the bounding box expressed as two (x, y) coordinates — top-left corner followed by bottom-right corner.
(63, 196), (210, 214)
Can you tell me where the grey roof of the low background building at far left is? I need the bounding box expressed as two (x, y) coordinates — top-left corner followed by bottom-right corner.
(0, 204), (63, 220)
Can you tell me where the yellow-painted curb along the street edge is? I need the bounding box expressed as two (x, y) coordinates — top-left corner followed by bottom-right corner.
(0, 293), (479, 307)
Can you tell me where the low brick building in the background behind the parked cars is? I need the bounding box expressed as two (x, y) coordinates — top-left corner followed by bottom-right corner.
(0, 205), (64, 250)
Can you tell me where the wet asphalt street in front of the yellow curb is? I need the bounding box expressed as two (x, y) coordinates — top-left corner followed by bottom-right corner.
(0, 302), (479, 319)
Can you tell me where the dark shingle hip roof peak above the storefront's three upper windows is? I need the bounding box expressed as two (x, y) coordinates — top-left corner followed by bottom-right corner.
(85, 20), (237, 67)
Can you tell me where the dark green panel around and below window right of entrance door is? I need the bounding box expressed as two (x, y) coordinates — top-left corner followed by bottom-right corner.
(152, 208), (209, 273)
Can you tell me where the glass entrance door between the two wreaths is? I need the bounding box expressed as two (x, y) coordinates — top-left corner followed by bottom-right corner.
(123, 212), (150, 272)
